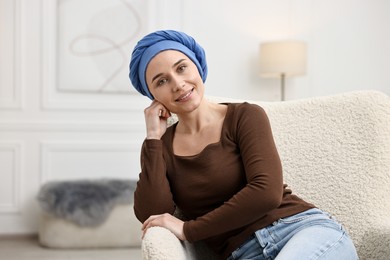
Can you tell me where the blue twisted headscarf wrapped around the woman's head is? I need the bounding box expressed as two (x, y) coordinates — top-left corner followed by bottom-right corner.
(129, 30), (207, 100)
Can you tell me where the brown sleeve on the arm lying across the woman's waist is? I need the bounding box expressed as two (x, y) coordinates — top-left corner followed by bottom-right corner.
(184, 104), (283, 242)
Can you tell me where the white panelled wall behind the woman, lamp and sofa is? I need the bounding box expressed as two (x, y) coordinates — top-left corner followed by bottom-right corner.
(0, 0), (390, 235)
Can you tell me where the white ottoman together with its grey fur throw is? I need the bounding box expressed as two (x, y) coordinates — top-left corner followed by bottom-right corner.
(38, 180), (142, 249)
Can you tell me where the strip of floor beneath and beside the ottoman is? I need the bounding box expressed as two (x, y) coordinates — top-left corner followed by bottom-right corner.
(0, 236), (141, 260)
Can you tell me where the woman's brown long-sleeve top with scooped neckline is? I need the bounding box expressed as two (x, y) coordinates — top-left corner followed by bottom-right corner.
(134, 103), (314, 258)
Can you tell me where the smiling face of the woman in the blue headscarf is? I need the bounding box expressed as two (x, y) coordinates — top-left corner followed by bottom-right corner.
(146, 50), (204, 114)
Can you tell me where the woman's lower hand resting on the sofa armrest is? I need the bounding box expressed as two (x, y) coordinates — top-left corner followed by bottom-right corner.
(142, 213), (186, 241)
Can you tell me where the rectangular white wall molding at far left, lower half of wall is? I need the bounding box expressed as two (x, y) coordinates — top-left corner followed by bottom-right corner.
(0, 141), (23, 214)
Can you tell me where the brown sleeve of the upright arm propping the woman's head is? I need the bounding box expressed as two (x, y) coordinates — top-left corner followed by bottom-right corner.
(134, 140), (175, 223)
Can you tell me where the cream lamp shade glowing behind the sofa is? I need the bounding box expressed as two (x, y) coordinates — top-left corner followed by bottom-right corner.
(259, 41), (306, 77)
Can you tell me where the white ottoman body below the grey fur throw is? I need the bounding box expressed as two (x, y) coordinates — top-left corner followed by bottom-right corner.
(38, 204), (142, 248)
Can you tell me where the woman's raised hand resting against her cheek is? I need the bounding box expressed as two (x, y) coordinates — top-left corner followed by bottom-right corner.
(144, 100), (171, 139)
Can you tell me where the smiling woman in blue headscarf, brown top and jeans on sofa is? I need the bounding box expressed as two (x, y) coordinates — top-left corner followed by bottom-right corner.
(130, 30), (357, 260)
